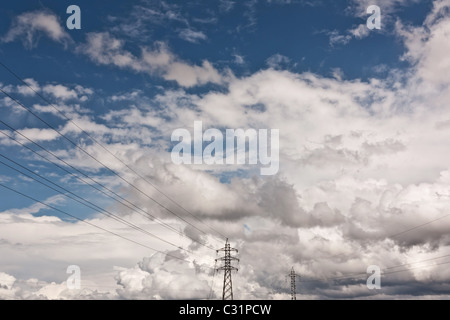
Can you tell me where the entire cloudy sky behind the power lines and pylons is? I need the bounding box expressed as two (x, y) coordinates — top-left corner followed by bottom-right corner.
(0, 0), (450, 299)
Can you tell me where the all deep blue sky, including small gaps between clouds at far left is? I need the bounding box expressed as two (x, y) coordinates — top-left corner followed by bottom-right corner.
(0, 1), (431, 213)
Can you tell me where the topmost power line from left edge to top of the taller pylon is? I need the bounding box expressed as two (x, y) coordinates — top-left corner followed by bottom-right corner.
(0, 61), (227, 239)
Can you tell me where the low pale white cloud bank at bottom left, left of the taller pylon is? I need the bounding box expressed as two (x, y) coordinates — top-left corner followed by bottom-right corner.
(0, 197), (218, 299)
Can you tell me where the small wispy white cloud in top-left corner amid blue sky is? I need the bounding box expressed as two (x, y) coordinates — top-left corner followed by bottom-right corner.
(2, 10), (71, 49)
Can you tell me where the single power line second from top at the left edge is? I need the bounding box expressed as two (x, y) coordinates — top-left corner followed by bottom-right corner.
(0, 88), (221, 242)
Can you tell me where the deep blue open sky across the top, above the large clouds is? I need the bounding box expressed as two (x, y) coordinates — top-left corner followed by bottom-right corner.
(1, 1), (431, 84)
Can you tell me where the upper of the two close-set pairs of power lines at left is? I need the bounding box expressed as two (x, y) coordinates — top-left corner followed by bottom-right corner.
(0, 120), (215, 250)
